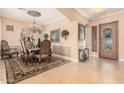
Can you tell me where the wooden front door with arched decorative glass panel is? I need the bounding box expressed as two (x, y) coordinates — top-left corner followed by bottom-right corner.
(99, 21), (118, 59)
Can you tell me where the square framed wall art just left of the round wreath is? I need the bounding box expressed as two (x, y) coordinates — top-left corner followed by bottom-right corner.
(50, 29), (60, 43)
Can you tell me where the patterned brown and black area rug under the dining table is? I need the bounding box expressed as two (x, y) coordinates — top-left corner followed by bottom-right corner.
(4, 57), (69, 84)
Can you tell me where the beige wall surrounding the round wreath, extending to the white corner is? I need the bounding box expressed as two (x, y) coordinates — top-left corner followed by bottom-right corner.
(45, 18), (78, 60)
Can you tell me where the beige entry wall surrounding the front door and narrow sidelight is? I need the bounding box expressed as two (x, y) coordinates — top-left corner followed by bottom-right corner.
(88, 12), (124, 59)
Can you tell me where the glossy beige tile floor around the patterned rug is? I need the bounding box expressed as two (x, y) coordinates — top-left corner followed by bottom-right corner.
(0, 58), (124, 84)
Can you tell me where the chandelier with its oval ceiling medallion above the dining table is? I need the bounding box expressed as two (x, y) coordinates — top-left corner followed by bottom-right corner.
(23, 10), (42, 34)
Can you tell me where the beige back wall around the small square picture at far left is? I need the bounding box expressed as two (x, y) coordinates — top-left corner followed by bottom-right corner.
(1, 17), (41, 46)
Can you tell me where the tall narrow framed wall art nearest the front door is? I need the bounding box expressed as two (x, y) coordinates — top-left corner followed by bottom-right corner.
(78, 23), (85, 40)
